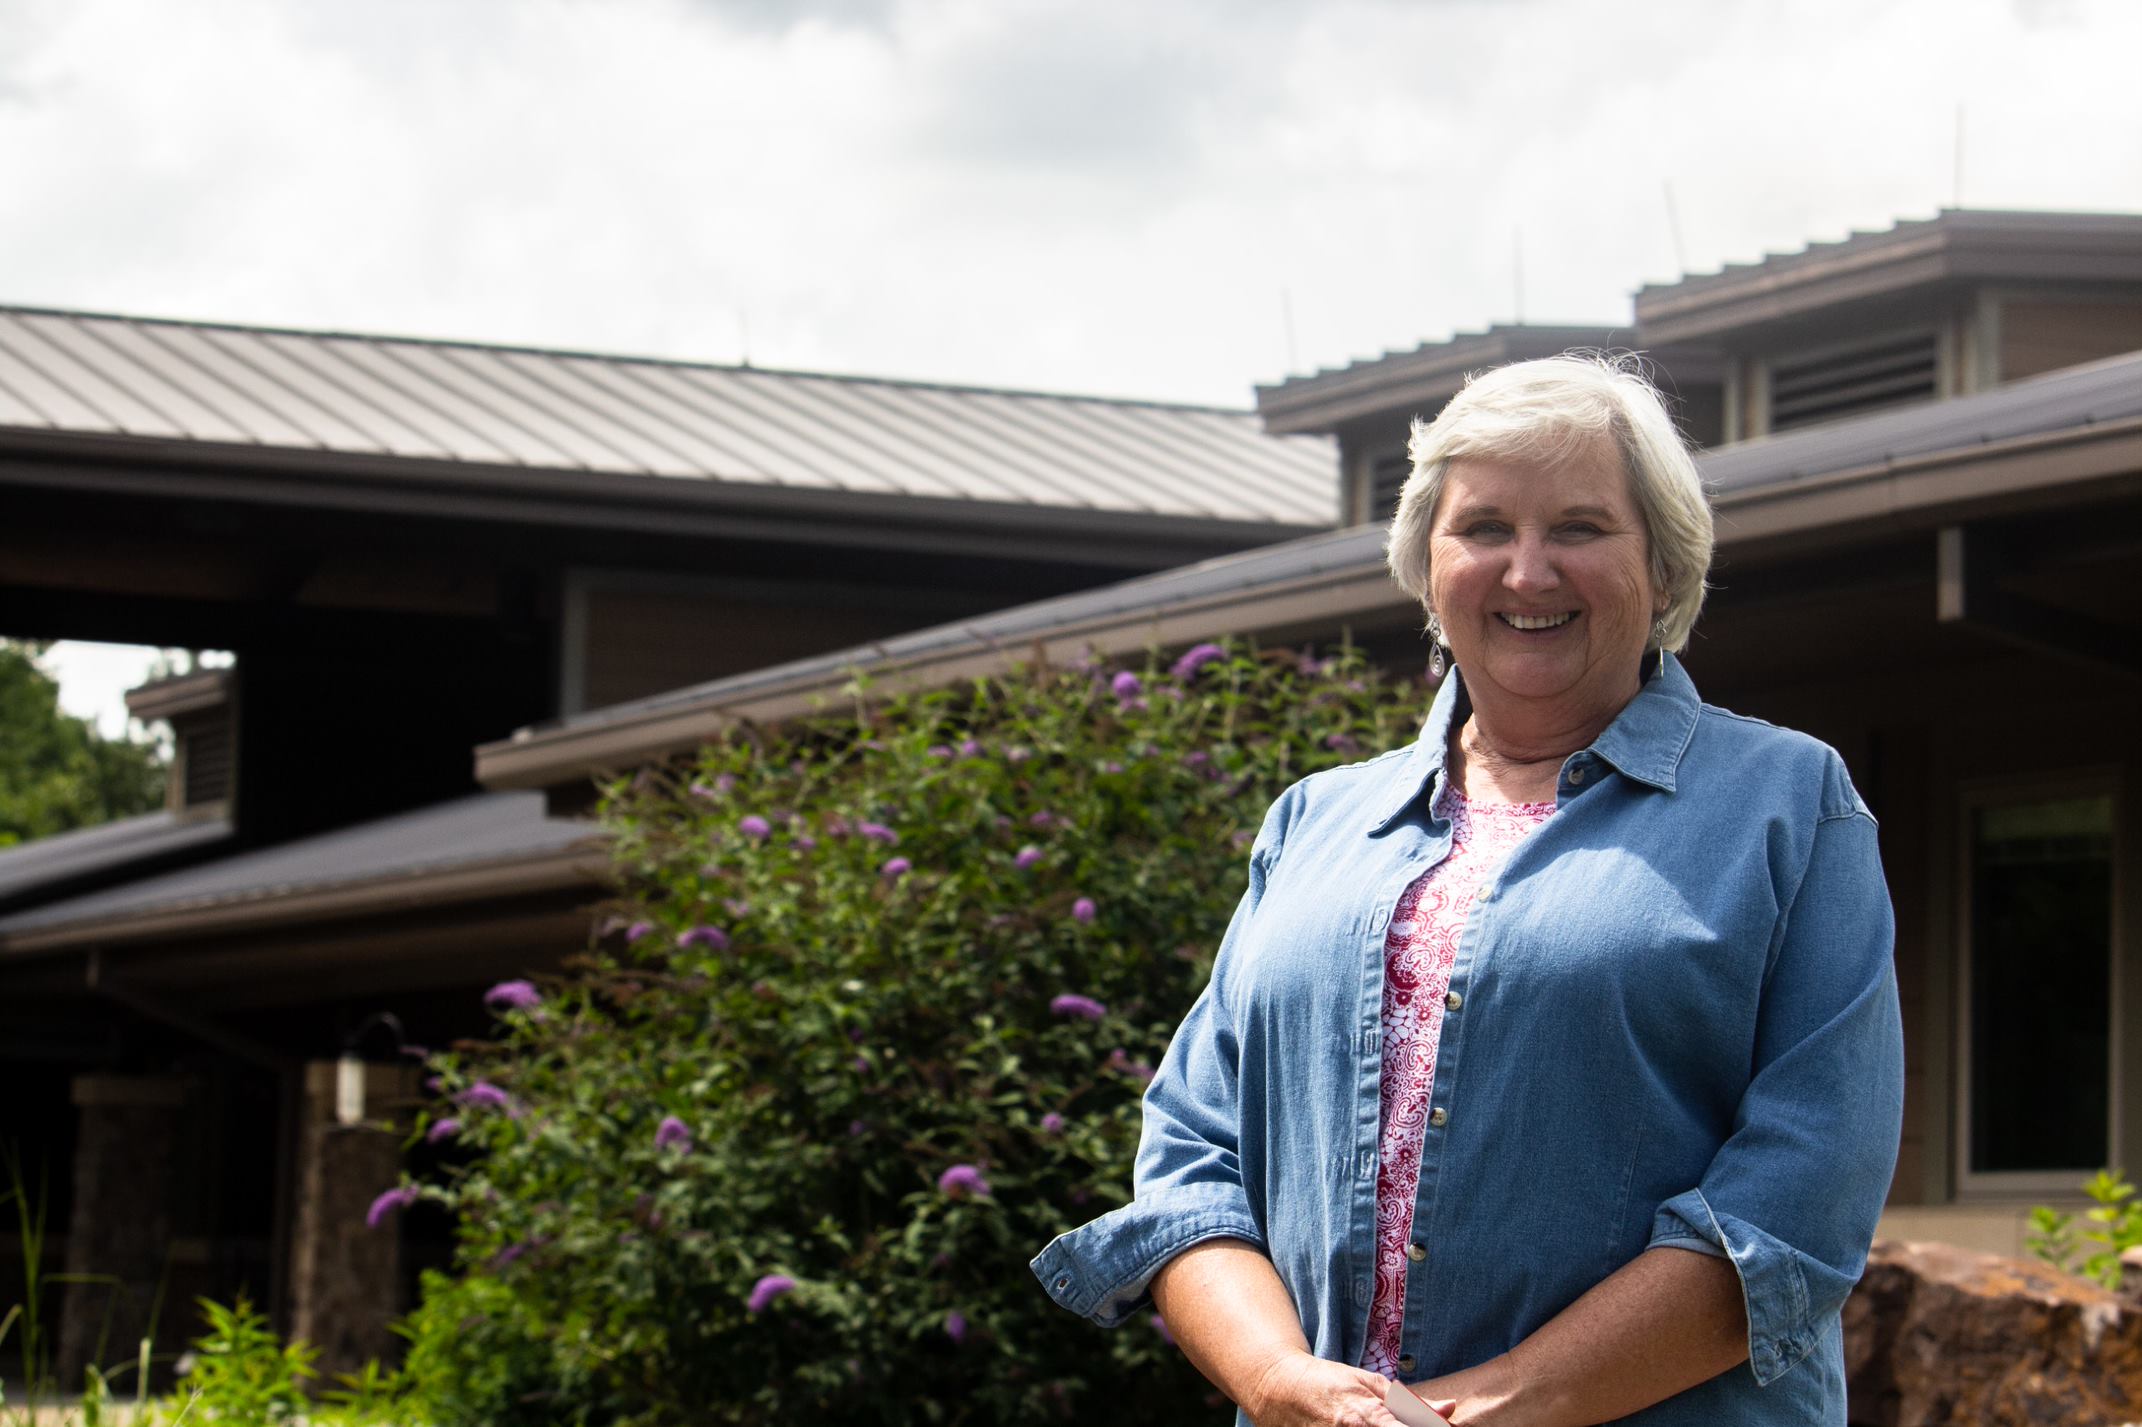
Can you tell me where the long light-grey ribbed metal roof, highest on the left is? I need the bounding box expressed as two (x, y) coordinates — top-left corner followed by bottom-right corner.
(0, 306), (1339, 527)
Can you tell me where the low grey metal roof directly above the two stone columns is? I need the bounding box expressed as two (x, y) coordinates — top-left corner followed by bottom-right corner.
(0, 793), (602, 949)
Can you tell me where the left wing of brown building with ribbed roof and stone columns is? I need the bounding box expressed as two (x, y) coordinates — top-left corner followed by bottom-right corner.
(0, 309), (1332, 1382)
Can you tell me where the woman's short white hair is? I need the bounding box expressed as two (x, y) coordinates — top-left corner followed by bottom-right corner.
(1386, 351), (1714, 651)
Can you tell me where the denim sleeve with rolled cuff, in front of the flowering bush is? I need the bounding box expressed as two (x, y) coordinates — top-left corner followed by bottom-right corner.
(1030, 797), (1287, 1328)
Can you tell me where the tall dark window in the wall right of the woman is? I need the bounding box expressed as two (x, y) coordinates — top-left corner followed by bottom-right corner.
(1960, 788), (2112, 1191)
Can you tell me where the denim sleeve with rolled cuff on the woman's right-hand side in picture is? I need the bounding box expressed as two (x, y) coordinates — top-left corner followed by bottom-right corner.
(1649, 808), (1904, 1386)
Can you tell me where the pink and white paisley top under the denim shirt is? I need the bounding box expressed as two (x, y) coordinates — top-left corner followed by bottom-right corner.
(1360, 788), (1555, 1378)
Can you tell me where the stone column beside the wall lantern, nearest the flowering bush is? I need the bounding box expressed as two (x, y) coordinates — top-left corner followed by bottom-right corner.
(289, 1061), (416, 1382)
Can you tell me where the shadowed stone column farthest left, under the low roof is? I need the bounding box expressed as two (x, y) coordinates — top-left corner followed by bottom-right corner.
(54, 1076), (188, 1393)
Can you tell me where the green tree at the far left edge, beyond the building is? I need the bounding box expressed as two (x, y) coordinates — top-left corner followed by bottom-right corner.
(0, 639), (165, 846)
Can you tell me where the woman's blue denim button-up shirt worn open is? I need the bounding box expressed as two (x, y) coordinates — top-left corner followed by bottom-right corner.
(1032, 656), (1904, 1425)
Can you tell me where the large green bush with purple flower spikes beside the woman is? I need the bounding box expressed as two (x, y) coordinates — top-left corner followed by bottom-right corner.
(405, 651), (1422, 1427)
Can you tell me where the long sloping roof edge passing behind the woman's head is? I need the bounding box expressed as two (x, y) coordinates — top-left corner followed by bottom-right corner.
(478, 351), (2142, 782)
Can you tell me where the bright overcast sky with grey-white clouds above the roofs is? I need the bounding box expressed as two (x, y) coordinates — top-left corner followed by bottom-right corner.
(0, 0), (2142, 732)
